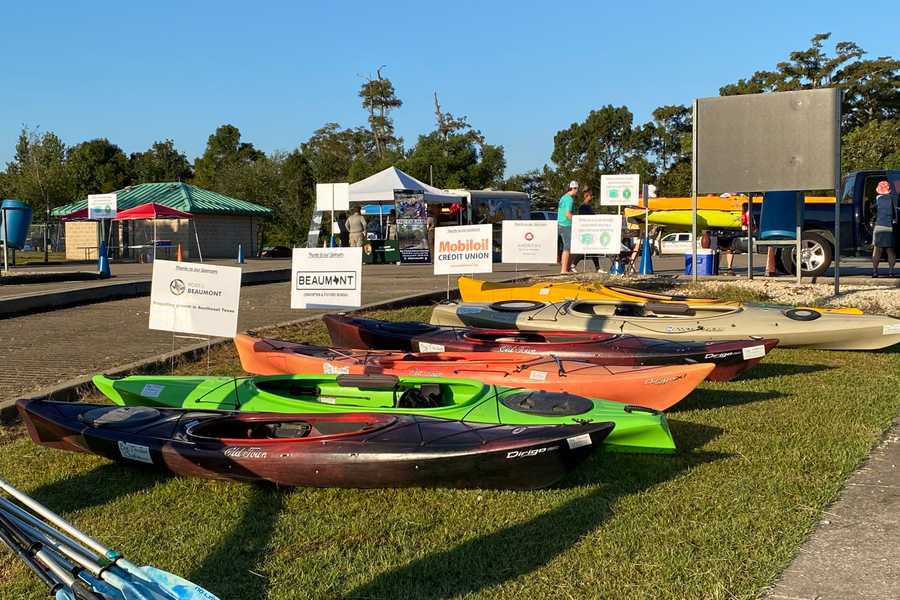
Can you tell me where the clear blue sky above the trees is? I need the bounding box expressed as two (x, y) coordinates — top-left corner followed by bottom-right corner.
(0, 0), (900, 174)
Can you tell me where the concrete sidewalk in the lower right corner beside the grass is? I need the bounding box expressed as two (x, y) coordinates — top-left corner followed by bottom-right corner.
(767, 419), (900, 600)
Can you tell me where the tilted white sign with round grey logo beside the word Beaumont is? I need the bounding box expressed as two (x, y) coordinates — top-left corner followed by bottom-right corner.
(150, 260), (241, 337)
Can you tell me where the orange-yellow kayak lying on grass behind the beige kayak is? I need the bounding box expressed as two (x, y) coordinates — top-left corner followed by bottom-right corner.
(456, 277), (863, 315)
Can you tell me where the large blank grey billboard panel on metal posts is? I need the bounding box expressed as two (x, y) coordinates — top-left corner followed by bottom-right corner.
(694, 88), (841, 194)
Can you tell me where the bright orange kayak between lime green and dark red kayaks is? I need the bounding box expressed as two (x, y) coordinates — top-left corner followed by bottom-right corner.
(234, 335), (715, 410)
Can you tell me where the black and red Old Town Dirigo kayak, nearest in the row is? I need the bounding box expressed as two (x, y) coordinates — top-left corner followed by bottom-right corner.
(17, 400), (613, 489)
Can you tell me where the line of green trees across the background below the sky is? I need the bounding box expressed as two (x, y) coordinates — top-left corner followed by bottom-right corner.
(0, 33), (900, 244)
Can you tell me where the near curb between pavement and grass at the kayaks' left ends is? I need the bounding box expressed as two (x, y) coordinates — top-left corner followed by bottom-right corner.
(0, 286), (459, 425)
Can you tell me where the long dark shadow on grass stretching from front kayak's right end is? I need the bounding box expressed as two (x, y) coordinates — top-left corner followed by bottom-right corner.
(342, 424), (728, 600)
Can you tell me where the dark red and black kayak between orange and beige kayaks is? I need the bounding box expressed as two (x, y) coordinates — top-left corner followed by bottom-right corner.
(323, 314), (778, 381)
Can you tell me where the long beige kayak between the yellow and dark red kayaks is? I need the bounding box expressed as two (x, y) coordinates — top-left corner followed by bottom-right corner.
(431, 300), (900, 350)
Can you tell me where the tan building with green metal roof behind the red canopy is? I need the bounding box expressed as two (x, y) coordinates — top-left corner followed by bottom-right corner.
(52, 182), (272, 260)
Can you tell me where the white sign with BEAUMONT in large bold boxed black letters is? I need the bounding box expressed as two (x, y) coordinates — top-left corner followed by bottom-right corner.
(291, 248), (362, 308)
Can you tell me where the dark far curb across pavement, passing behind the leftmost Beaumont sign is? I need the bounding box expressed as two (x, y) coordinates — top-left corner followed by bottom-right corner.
(0, 268), (291, 319)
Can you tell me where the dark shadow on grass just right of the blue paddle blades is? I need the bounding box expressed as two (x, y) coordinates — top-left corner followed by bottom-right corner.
(187, 484), (290, 600)
